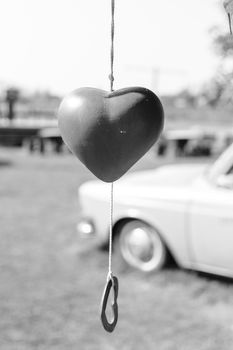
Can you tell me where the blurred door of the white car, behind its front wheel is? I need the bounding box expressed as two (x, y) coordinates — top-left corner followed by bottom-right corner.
(189, 167), (233, 276)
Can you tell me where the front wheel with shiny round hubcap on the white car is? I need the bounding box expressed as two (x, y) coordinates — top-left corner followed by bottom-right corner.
(117, 220), (168, 272)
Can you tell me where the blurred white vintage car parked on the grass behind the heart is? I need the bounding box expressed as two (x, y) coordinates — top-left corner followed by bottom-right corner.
(77, 145), (233, 277)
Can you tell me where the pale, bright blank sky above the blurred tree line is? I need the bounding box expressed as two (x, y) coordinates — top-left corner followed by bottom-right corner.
(0, 0), (229, 95)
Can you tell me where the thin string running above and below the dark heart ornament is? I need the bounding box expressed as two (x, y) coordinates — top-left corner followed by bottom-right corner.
(108, 0), (115, 278)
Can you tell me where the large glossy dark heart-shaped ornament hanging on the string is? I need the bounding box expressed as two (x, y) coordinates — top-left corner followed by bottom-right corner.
(58, 87), (164, 182)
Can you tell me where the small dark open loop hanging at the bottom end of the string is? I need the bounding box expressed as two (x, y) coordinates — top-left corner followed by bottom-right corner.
(101, 276), (119, 333)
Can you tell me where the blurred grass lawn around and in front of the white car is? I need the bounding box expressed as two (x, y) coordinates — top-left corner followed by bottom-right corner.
(0, 149), (233, 350)
